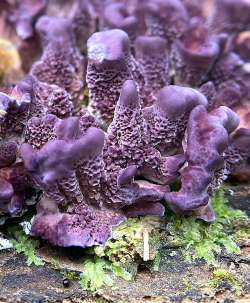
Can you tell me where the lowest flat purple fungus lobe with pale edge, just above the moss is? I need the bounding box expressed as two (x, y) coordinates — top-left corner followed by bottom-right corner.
(31, 206), (125, 247)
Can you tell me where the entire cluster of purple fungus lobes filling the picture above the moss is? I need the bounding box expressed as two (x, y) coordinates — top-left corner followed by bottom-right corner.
(0, 0), (250, 247)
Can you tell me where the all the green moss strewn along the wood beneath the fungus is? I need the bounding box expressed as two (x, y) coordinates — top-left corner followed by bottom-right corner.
(4, 189), (249, 292)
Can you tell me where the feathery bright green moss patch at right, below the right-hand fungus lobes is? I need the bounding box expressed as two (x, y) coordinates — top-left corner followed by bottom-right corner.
(164, 189), (248, 265)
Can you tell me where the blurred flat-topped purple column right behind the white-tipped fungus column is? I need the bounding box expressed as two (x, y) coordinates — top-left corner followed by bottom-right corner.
(135, 36), (170, 106)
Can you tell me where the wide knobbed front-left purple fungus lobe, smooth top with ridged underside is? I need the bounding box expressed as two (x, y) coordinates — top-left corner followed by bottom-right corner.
(21, 117), (104, 208)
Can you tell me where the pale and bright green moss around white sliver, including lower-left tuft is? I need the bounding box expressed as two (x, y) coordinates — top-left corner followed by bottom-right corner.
(80, 217), (166, 291)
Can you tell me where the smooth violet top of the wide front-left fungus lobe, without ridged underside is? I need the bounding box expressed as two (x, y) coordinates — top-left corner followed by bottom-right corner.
(21, 125), (104, 188)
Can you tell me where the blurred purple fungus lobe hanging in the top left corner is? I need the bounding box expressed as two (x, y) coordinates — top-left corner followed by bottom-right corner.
(10, 0), (48, 40)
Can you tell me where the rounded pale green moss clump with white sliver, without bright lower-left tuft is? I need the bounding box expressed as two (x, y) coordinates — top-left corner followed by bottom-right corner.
(94, 217), (162, 277)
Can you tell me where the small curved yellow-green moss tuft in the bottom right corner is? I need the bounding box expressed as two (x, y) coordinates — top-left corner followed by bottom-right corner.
(208, 268), (242, 296)
